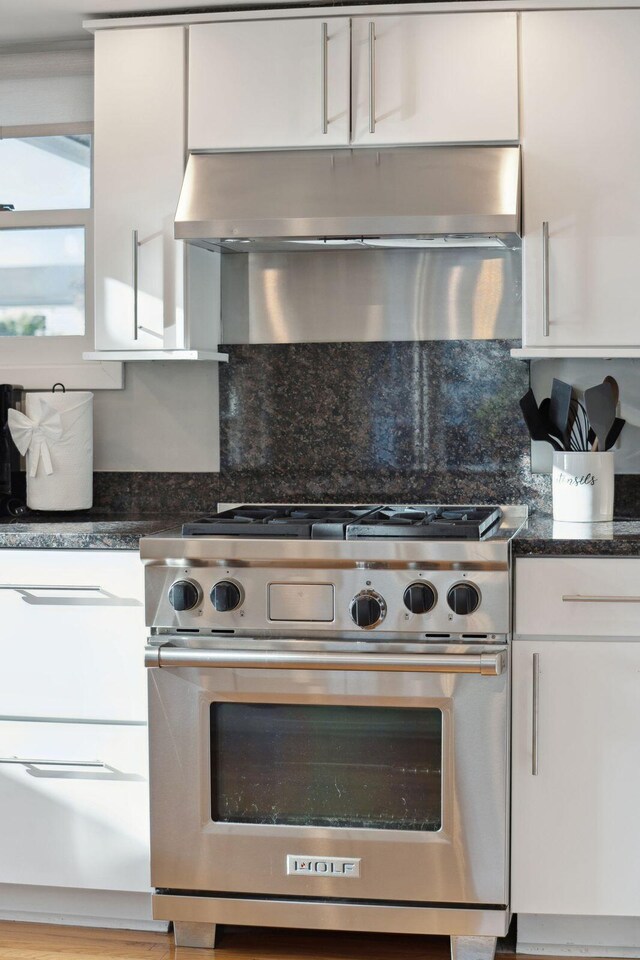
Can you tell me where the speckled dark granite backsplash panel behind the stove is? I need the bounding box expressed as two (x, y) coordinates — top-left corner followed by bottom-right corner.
(220, 340), (550, 504)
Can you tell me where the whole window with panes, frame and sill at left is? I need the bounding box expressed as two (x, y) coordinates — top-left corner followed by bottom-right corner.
(0, 122), (119, 390)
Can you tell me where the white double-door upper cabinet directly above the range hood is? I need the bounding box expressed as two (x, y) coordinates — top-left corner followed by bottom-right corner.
(189, 13), (518, 150)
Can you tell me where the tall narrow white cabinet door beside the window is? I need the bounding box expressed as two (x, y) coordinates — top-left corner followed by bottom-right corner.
(94, 27), (186, 350)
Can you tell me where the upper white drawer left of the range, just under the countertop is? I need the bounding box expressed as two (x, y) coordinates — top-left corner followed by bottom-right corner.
(0, 550), (146, 721)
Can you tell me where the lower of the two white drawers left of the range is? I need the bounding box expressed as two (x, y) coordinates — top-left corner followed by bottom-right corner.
(0, 720), (150, 892)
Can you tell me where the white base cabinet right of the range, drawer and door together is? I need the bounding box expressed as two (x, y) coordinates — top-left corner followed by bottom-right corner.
(511, 557), (640, 916)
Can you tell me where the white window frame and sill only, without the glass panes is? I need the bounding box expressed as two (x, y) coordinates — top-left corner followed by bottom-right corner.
(0, 122), (124, 390)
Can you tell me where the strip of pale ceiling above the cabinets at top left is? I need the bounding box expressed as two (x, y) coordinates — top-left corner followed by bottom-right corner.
(0, 0), (262, 47)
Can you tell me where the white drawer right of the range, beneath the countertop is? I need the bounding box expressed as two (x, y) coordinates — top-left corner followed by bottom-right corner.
(515, 557), (640, 637)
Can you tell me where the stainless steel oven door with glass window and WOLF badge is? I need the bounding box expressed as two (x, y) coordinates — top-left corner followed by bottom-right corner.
(147, 637), (509, 905)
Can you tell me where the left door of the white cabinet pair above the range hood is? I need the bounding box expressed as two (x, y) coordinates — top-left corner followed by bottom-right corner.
(189, 17), (350, 150)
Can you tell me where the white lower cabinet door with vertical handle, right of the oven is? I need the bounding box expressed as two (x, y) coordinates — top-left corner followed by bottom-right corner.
(511, 640), (640, 916)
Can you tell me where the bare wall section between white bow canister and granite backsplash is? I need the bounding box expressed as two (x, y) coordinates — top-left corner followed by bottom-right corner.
(93, 361), (219, 472)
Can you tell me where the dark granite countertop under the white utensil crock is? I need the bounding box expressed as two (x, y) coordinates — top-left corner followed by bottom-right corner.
(513, 512), (640, 557)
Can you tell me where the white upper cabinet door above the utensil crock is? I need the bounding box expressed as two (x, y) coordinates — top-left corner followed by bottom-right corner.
(521, 10), (640, 347)
